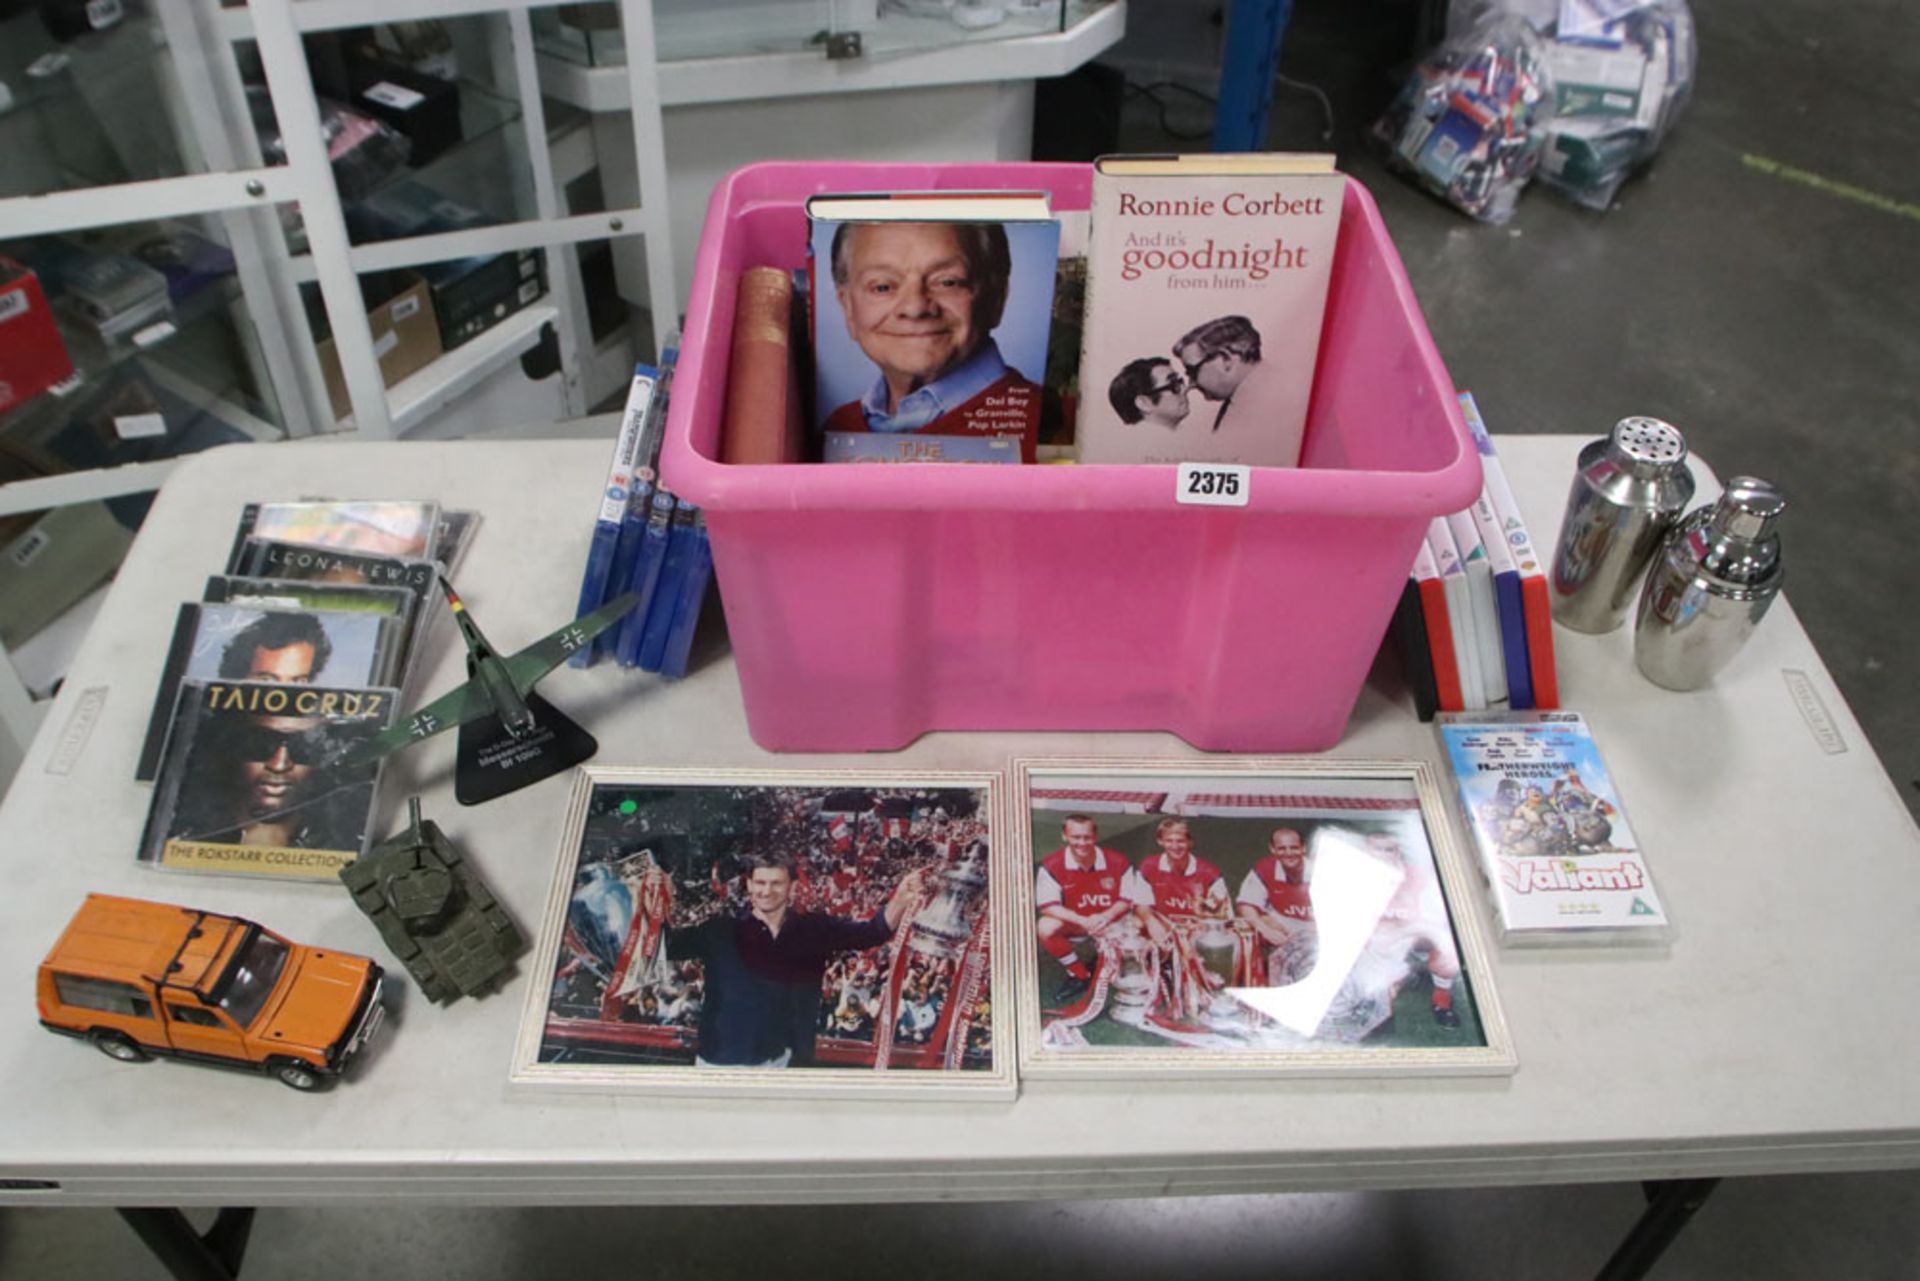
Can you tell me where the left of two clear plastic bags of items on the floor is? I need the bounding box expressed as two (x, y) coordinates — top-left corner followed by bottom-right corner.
(1373, 12), (1553, 223)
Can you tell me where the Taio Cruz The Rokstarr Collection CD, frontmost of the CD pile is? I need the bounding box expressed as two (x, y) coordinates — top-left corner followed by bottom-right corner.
(140, 680), (399, 880)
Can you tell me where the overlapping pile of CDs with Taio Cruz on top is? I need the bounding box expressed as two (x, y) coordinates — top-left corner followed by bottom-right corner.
(134, 501), (478, 880)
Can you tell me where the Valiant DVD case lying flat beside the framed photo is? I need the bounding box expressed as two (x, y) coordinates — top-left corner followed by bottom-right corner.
(1434, 713), (1672, 945)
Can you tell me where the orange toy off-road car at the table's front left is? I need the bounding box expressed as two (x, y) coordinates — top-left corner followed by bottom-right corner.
(36, 895), (382, 1089)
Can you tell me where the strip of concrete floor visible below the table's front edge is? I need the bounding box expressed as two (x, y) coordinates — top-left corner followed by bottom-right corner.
(0, 1173), (1920, 1281)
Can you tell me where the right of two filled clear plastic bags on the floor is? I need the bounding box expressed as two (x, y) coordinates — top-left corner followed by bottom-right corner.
(1540, 0), (1697, 209)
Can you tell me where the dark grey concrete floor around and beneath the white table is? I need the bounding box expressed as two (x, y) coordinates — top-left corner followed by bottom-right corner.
(0, 0), (1920, 1281)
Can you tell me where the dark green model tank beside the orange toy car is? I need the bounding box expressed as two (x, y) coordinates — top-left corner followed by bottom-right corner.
(340, 797), (524, 1003)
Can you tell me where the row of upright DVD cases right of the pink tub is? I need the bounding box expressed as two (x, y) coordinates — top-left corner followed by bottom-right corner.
(1392, 392), (1559, 720)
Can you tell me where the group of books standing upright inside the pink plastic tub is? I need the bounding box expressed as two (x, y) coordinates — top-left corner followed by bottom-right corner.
(706, 154), (1346, 467)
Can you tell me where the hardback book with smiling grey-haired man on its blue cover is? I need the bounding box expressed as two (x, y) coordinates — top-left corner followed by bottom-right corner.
(806, 192), (1060, 463)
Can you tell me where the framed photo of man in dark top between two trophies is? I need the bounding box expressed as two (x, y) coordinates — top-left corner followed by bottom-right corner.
(513, 766), (1016, 1099)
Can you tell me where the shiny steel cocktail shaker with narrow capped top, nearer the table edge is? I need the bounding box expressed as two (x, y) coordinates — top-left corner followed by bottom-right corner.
(1634, 476), (1788, 689)
